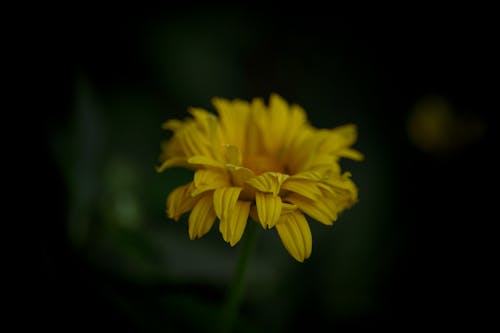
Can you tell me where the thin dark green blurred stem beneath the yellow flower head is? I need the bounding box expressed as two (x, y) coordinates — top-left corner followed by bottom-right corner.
(221, 220), (259, 333)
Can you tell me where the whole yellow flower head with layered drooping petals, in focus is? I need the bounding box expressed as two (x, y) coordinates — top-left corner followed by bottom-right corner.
(157, 94), (363, 262)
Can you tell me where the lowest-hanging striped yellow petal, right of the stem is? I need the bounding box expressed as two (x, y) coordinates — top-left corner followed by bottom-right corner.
(276, 212), (312, 262)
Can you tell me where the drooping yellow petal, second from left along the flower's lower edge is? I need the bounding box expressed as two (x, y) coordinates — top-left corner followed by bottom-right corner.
(189, 193), (215, 240)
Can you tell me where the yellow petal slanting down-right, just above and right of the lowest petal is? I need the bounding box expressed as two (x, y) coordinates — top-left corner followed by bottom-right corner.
(286, 193), (337, 225)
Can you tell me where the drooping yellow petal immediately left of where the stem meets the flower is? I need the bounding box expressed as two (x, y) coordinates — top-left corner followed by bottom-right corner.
(219, 201), (251, 246)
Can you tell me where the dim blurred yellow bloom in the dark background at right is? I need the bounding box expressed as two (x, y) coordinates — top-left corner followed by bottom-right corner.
(407, 96), (486, 154)
